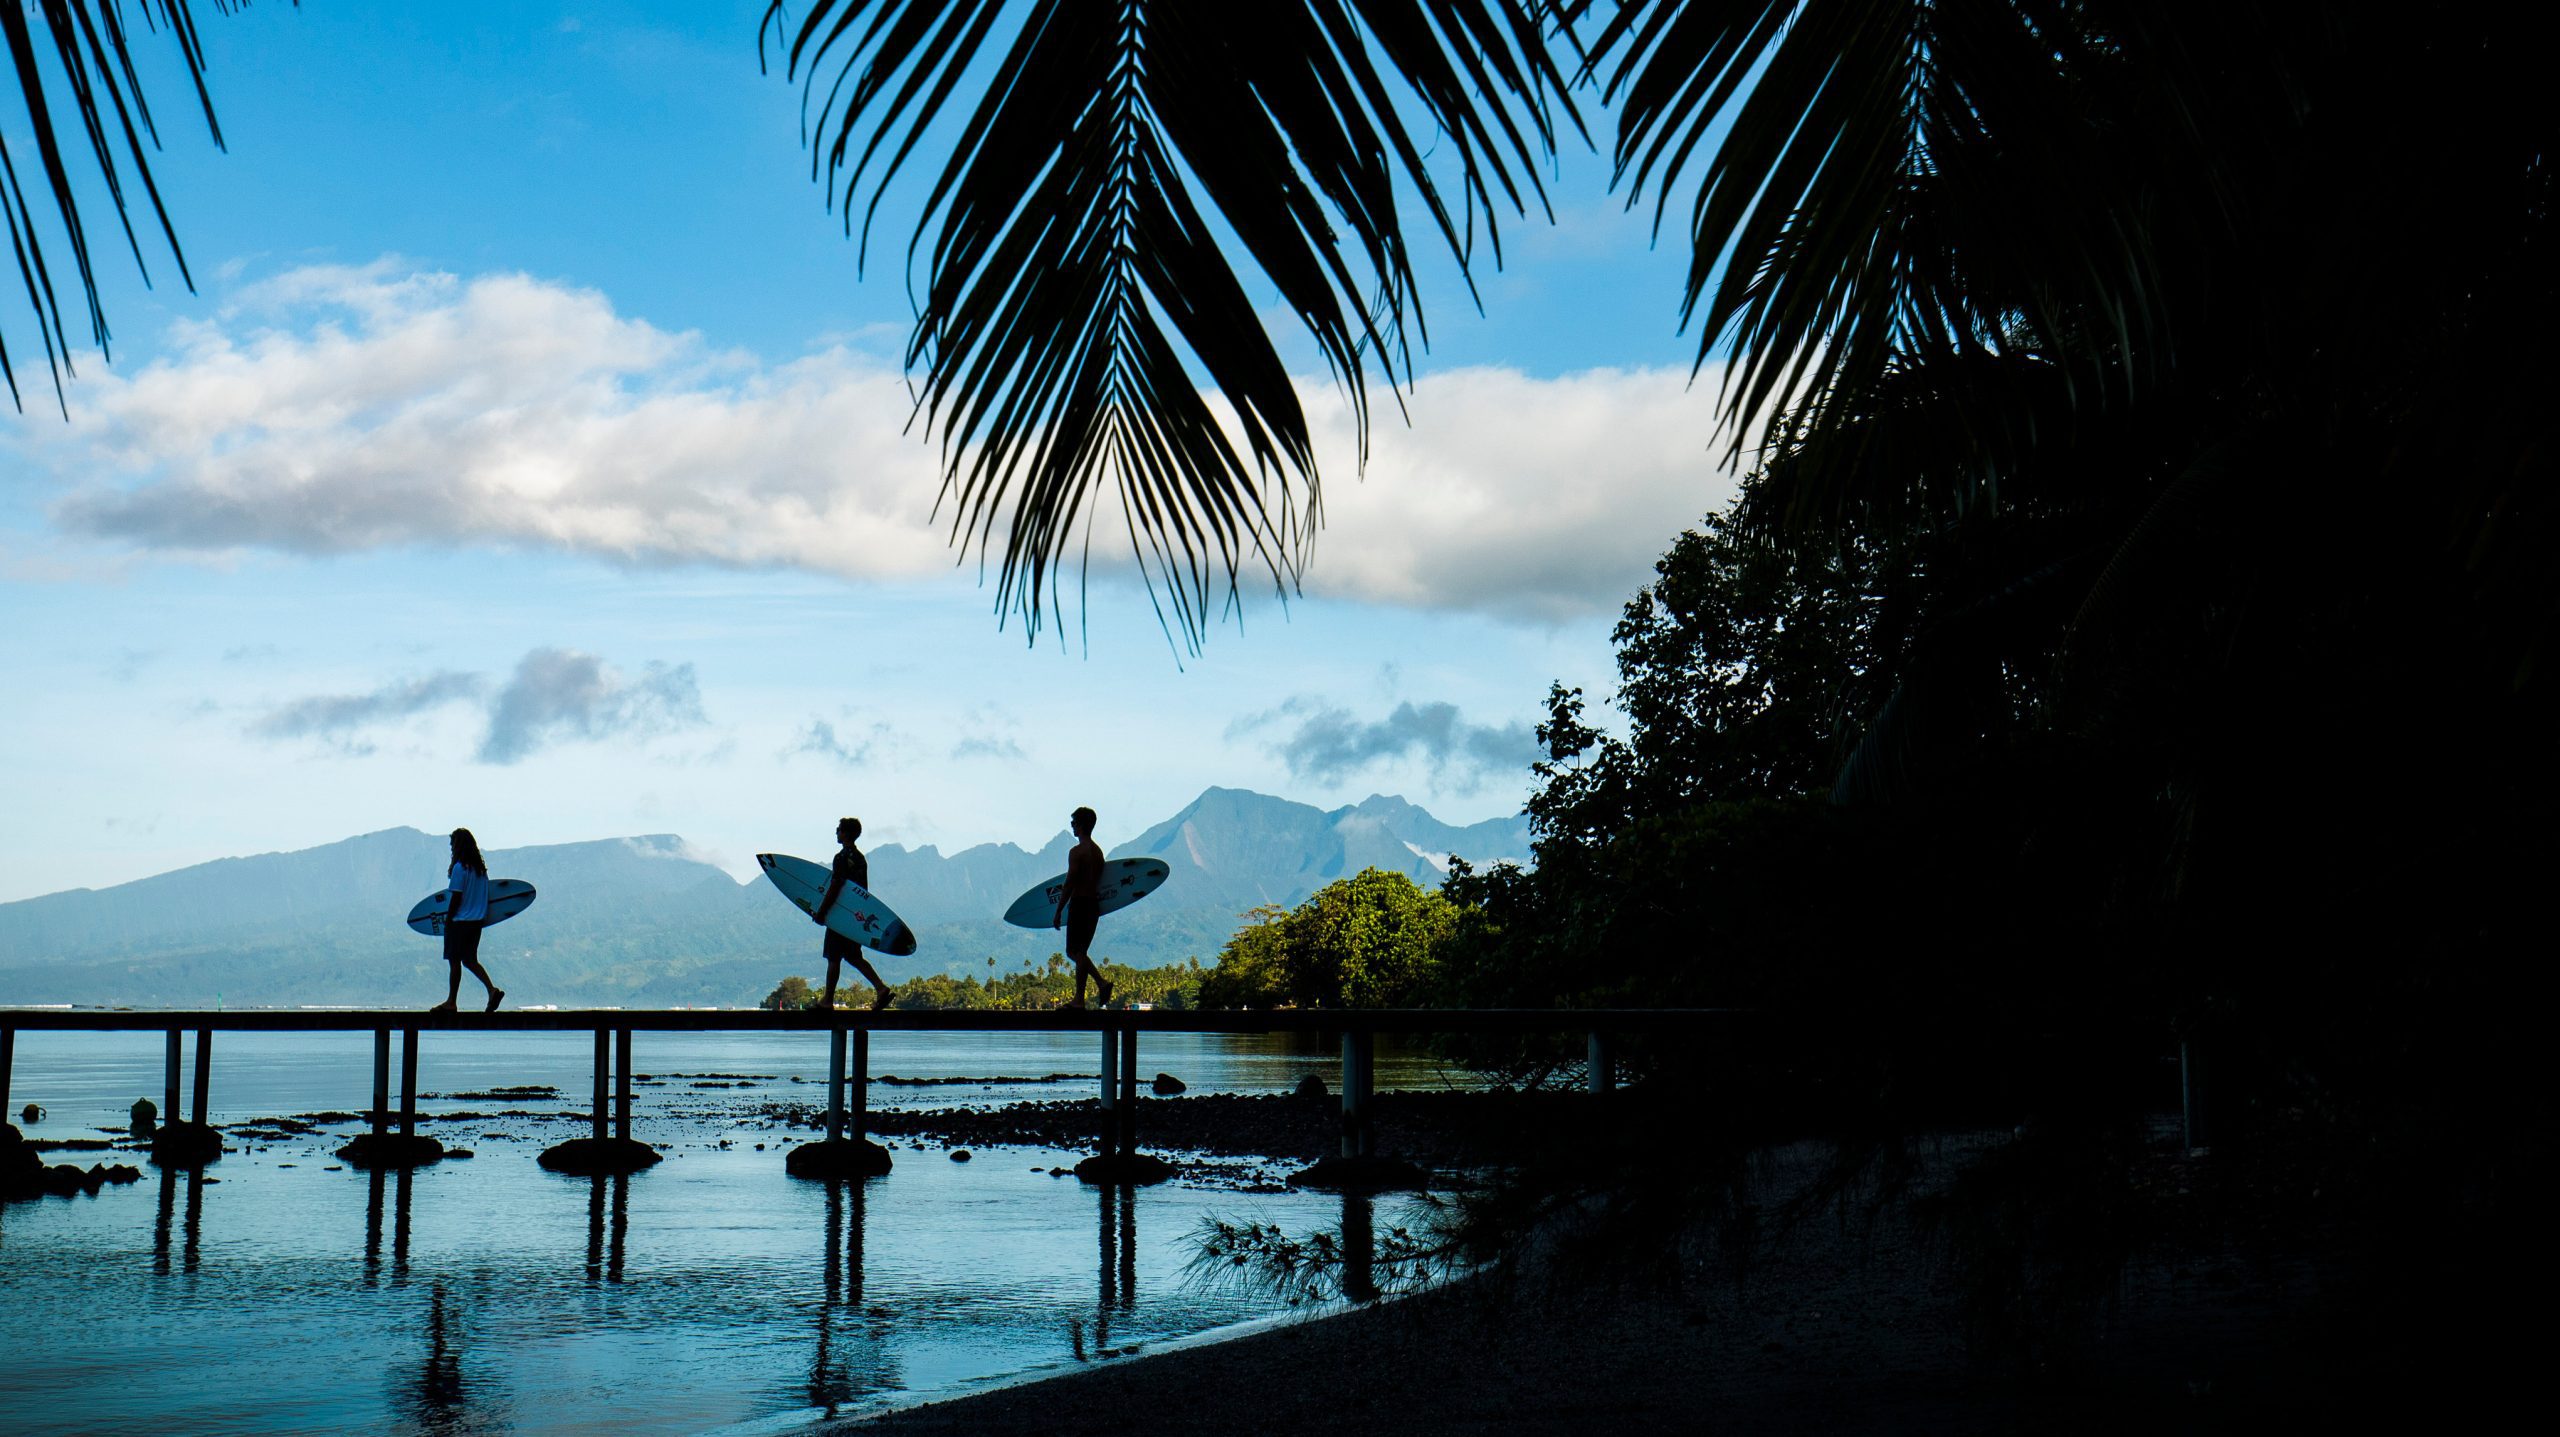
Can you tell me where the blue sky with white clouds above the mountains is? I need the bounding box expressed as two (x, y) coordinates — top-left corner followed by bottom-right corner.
(0, 0), (1731, 902)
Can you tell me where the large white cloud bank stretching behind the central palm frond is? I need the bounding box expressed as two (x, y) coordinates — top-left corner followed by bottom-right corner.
(13, 261), (1731, 620)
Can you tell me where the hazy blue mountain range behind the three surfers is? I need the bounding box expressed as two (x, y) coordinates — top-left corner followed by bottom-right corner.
(0, 789), (1528, 1007)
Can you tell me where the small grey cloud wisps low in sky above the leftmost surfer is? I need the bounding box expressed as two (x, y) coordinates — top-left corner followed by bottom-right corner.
(248, 648), (707, 766)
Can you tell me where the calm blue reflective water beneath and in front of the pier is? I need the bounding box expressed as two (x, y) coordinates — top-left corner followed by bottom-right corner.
(0, 1032), (1459, 1432)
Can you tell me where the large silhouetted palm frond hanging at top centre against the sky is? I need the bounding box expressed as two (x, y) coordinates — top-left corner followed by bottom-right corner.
(765, 0), (1572, 643)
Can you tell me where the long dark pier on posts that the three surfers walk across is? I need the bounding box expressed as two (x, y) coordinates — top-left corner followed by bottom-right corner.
(0, 1009), (1741, 1178)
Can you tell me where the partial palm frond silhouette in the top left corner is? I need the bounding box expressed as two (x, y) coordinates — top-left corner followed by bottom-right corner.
(0, 0), (248, 412)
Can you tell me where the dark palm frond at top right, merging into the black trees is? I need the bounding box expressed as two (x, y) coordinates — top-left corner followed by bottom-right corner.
(1592, 0), (2227, 486)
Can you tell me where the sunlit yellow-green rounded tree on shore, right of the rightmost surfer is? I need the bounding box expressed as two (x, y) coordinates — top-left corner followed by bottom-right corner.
(1201, 868), (1457, 1009)
